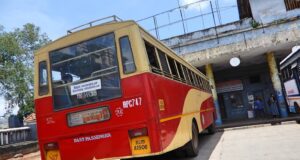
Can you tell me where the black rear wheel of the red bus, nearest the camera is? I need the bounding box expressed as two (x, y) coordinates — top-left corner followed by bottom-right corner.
(186, 122), (199, 157)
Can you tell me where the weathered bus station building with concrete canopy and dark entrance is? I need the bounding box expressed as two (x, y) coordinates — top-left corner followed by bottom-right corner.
(162, 0), (300, 125)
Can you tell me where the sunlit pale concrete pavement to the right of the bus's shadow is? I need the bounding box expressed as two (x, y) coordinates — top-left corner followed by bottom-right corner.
(209, 124), (300, 160)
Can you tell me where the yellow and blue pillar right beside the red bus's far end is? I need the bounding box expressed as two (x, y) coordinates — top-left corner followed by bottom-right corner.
(205, 64), (222, 126)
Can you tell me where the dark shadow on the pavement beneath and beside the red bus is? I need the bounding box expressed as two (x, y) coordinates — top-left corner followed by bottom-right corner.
(126, 132), (223, 160)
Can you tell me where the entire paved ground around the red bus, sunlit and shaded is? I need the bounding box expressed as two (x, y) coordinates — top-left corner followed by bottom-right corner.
(9, 123), (300, 160)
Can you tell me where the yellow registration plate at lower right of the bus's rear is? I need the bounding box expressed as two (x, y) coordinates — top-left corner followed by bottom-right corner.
(131, 136), (151, 155)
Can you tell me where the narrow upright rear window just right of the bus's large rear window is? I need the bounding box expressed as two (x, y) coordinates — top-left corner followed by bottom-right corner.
(120, 36), (136, 74)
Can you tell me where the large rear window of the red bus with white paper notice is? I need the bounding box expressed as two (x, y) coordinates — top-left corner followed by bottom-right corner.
(50, 33), (121, 110)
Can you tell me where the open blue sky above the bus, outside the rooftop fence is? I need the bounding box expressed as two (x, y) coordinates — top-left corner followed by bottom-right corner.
(0, 0), (177, 39)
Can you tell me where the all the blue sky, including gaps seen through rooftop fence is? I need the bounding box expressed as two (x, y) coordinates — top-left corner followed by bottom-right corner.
(0, 0), (238, 116)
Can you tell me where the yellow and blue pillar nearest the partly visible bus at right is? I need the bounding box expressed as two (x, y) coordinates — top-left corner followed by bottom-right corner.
(267, 52), (288, 117)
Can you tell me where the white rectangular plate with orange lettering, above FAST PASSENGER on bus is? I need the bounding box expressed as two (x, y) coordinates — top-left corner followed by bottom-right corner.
(68, 107), (110, 127)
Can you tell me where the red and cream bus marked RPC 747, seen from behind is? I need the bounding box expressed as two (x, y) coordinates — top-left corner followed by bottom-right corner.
(34, 17), (216, 160)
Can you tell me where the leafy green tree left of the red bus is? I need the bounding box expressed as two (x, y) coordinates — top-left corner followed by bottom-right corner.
(0, 24), (50, 116)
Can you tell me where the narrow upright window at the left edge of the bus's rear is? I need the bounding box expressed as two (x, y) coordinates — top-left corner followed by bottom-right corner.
(39, 61), (49, 96)
